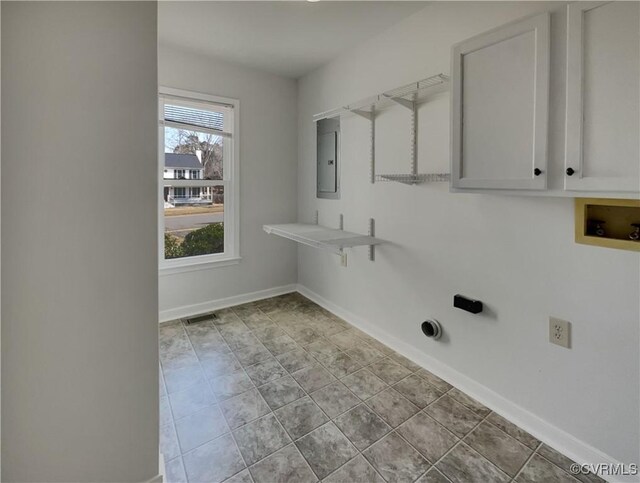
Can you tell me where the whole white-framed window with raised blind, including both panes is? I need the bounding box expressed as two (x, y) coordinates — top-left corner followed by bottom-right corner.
(159, 88), (239, 273)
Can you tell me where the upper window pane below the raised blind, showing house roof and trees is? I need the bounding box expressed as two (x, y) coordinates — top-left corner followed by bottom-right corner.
(164, 127), (225, 180)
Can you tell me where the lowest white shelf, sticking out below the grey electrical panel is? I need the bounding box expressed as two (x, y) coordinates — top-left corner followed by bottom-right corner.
(262, 223), (385, 254)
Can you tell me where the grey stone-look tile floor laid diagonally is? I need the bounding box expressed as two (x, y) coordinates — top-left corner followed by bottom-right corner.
(160, 294), (602, 483)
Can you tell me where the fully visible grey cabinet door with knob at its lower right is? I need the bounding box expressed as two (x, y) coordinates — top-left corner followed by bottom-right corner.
(451, 13), (550, 189)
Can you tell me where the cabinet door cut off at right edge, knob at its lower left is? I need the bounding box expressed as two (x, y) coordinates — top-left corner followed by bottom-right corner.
(565, 2), (640, 192)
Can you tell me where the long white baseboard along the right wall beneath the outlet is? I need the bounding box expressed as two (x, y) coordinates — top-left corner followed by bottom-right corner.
(297, 284), (638, 483)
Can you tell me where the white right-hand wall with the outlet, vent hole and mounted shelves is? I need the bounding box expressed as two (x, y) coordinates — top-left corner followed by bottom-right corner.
(298, 2), (640, 463)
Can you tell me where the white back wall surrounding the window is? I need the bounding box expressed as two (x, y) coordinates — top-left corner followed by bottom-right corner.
(159, 43), (297, 320)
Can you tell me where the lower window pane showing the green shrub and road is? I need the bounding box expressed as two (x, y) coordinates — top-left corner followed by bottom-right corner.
(164, 186), (224, 259)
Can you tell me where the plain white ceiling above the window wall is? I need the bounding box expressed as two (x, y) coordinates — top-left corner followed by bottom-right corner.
(158, 1), (427, 78)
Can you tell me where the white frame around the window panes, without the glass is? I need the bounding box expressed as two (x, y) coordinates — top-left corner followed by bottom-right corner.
(158, 87), (241, 276)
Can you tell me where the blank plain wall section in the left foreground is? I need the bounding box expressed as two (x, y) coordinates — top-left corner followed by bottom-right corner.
(2, 2), (158, 482)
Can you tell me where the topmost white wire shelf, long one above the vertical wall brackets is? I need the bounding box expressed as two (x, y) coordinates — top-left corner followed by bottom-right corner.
(313, 74), (449, 121)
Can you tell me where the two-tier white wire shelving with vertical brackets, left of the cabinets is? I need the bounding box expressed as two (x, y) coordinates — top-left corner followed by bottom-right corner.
(313, 74), (449, 185)
